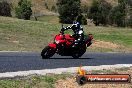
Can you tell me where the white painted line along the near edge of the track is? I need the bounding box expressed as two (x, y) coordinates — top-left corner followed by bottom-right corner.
(0, 64), (132, 78)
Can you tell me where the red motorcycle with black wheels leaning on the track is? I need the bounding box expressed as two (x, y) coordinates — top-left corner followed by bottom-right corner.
(41, 26), (93, 59)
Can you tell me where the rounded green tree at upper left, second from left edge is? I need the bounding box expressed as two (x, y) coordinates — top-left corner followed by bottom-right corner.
(15, 0), (32, 20)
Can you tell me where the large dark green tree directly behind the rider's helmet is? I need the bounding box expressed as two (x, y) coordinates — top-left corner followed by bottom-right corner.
(57, 0), (81, 23)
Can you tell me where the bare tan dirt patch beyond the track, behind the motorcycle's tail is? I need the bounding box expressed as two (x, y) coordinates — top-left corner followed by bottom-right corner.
(89, 40), (132, 53)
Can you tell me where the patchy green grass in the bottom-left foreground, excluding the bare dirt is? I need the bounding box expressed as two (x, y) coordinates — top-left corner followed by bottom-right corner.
(0, 74), (71, 88)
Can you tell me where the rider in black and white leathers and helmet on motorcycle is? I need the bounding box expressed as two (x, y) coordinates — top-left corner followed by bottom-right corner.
(64, 21), (84, 47)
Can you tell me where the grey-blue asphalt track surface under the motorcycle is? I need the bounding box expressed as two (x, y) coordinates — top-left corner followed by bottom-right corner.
(0, 52), (132, 73)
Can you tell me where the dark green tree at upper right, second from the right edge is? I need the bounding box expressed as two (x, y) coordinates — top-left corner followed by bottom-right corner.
(88, 0), (112, 26)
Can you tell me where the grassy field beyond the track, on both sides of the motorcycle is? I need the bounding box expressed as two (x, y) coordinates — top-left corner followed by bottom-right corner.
(0, 16), (132, 52)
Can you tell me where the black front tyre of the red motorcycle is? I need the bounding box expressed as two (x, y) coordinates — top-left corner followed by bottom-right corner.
(41, 46), (55, 59)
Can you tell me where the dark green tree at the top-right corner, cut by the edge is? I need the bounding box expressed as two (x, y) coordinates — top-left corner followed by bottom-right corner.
(110, 0), (132, 27)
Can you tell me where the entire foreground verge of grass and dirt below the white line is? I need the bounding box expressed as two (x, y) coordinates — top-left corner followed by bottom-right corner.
(0, 67), (132, 88)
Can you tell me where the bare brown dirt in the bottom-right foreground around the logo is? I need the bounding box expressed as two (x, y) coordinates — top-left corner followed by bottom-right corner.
(55, 67), (132, 88)
